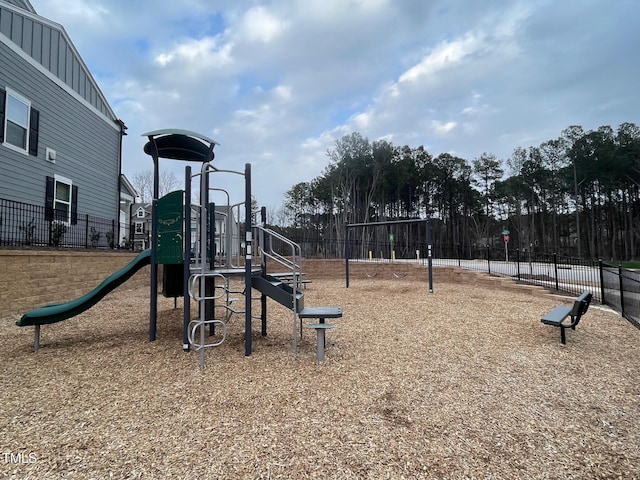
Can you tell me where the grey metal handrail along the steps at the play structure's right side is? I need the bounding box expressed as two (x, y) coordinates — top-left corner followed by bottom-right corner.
(254, 225), (302, 352)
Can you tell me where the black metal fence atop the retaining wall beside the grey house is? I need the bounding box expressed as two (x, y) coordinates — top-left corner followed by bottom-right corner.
(0, 198), (129, 248)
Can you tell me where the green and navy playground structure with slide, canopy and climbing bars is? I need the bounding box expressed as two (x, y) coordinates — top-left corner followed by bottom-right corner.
(16, 129), (342, 366)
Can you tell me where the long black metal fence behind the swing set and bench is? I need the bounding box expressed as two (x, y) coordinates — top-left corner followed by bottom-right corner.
(294, 238), (640, 328)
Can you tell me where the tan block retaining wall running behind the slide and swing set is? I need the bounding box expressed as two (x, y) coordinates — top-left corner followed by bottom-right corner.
(0, 250), (536, 318)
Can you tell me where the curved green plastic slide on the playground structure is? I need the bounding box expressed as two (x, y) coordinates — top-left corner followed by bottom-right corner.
(16, 249), (151, 327)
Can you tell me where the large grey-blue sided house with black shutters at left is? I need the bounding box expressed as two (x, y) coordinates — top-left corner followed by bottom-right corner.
(0, 0), (126, 244)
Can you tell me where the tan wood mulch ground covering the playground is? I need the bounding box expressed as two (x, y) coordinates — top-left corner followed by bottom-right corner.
(0, 278), (640, 479)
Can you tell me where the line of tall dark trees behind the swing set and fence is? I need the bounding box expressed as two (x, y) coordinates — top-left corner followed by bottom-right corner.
(281, 123), (640, 260)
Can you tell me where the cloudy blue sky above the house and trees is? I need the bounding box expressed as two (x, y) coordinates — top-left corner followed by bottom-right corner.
(31, 0), (640, 208)
